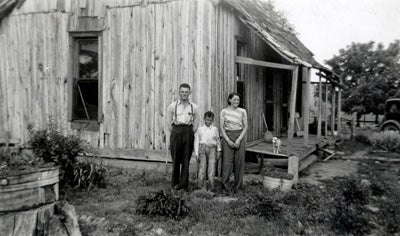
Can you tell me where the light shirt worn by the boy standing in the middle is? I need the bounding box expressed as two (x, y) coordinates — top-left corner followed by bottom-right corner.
(194, 125), (221, 156)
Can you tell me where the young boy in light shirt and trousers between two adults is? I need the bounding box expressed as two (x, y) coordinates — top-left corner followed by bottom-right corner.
(194, 111), (221, 190)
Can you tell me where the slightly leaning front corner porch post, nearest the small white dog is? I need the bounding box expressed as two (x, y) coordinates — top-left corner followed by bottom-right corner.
(286, 66), (299, 155)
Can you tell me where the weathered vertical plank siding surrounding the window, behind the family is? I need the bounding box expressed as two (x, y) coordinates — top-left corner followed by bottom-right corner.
(0, 0), (241, 150)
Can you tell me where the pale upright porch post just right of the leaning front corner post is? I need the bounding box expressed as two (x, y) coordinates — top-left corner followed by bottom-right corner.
(302, 67), (311, 145)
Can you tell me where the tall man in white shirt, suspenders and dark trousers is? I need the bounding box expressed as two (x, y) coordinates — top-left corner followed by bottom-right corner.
(167, 84), (199, 191)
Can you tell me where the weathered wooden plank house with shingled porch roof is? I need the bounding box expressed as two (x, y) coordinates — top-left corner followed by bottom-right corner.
(0, 0), (344, 166)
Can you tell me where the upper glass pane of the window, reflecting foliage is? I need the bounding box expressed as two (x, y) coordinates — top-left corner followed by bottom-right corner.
(79, 39), (99, 79)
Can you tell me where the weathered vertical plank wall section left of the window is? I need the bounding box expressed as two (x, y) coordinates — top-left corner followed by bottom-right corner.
(0, 12), (69, 142)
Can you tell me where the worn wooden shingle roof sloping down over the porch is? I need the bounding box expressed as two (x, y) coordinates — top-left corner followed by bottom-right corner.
(222, 0), (326, 69)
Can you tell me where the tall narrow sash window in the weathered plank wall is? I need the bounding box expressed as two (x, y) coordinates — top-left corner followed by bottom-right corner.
(71, 34), (101, 128)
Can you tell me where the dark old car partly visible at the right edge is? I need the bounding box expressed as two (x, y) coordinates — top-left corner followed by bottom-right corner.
(380, 98), (400, 131)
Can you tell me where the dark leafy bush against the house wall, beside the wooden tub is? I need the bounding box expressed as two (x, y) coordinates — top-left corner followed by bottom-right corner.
(29, 124), (106, 189)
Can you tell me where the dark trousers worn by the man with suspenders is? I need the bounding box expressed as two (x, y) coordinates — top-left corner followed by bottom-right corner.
(170, 125), (194, 190)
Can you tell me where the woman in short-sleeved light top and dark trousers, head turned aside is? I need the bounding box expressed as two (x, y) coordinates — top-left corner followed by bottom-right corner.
(220, 93), (247, 192)
